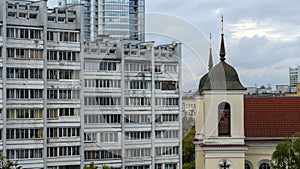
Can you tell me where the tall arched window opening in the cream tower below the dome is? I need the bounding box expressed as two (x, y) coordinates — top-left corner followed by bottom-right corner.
(218, 102), (230, 136)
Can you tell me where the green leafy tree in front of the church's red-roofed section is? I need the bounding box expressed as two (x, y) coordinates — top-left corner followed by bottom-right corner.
(271, 133), (300, 169)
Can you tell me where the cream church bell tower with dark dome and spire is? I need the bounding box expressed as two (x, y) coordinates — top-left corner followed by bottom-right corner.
(193, 16), (247, 169)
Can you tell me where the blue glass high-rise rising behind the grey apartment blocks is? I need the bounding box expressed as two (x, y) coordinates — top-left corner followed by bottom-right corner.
(59, 0), (145, 41)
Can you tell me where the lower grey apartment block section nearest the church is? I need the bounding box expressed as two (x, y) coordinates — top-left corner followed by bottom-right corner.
(84, 40), (182, 169)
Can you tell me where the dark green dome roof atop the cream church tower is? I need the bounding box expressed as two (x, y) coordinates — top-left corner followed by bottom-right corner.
(198, 60), (245, 93)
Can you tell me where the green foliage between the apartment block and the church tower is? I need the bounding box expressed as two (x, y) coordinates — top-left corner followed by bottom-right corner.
(182, 124), (195, 169)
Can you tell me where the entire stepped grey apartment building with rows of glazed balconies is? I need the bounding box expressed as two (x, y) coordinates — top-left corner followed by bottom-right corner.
(0, 0), (182, 169)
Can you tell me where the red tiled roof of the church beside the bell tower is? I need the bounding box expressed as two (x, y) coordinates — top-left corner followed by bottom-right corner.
(244, 97), (300, 137)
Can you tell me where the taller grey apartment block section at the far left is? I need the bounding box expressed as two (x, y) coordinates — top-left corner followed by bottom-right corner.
(0, 0), (84, 169)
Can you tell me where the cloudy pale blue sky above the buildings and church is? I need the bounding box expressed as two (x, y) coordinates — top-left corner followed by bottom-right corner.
(48, 0), (300, 91)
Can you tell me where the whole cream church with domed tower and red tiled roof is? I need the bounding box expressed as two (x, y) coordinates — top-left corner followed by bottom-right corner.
(193, 19), (300, 169)
